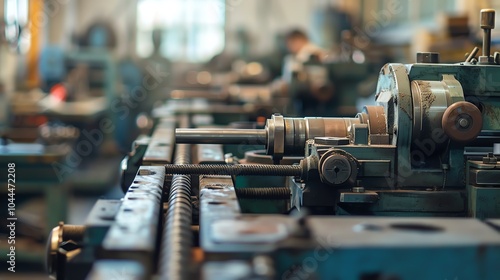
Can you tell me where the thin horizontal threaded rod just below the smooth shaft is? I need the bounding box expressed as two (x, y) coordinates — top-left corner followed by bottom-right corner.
(165, 164), (302, 176)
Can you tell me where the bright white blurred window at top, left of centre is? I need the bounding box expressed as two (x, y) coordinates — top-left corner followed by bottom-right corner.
(137, 0), (226, 62)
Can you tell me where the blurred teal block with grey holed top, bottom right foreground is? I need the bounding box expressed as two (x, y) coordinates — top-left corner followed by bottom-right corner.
(273, 217), (500, 280)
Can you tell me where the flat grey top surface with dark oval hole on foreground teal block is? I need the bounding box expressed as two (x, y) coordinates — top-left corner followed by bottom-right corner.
(308, 217), (500, 247)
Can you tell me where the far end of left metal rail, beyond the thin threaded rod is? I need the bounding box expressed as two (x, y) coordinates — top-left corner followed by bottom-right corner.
(143, 118), (176, 165)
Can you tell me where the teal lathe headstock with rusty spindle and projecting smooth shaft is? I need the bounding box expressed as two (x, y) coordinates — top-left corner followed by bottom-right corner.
(176, 10), (500, 218)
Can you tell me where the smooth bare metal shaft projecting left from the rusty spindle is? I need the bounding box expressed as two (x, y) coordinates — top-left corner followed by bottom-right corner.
(175, 128), (267, 145)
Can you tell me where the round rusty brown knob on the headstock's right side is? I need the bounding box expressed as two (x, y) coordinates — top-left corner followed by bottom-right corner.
(441, 101), (483, 142)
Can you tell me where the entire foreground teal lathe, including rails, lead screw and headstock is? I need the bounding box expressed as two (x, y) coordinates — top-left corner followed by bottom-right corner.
(47, 10), (500, 280)
